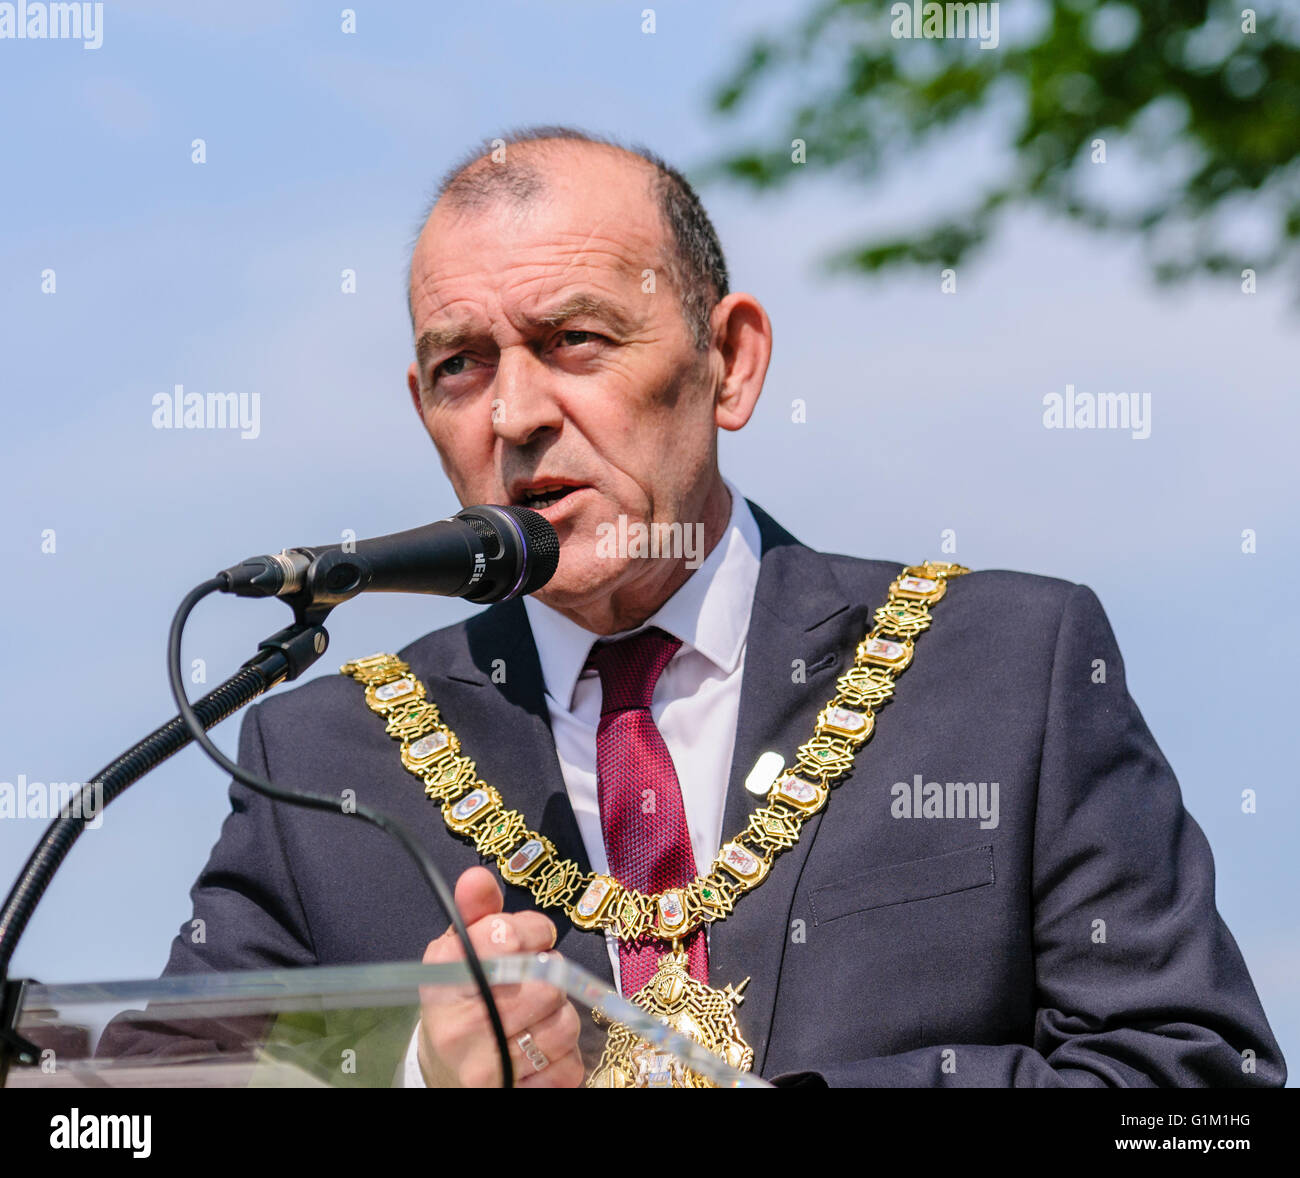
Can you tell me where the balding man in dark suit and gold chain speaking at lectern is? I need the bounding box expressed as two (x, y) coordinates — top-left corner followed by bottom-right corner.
(106, 129), (1284, 1087)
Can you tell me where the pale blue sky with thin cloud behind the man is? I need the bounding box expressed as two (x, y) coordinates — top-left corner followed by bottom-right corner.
(0, 0), (1300, 1081)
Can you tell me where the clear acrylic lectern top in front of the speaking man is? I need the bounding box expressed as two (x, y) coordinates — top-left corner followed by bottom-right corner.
(5, 953), (768, 1088)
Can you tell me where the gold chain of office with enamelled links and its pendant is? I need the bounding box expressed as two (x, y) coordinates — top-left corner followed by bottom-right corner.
(341, 560), (970, 1087)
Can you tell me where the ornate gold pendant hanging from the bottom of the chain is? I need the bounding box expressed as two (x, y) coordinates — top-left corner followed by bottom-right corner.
(586, 940), (754, 1088)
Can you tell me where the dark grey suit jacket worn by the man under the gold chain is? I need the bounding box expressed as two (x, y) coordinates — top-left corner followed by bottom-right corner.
(104, 504), (1286, 1087)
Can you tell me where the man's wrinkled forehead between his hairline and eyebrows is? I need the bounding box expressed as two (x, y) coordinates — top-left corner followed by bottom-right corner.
(411, 148), (664, 325)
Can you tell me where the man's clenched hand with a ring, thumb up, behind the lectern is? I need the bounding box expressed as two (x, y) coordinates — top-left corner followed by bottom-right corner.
(420, 867), (582, 1088)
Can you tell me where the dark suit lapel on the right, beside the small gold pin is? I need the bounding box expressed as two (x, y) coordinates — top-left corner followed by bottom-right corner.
(709, 503), (866, 1071)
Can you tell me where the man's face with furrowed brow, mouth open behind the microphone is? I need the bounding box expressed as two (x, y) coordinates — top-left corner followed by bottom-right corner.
(410, 146), (720, 609)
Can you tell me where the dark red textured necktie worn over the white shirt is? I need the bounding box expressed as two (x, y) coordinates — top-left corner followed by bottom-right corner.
(586, 627), (709, 997)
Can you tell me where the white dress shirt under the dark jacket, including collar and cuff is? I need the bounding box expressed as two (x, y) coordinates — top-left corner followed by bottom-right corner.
(404, 482), (762, 1087)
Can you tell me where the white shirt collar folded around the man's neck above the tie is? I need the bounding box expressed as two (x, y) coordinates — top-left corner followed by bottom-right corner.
(524, 480), (762, 710)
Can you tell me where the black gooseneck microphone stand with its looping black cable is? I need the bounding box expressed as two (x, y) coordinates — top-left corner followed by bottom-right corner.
(0, 573), (514, 1088)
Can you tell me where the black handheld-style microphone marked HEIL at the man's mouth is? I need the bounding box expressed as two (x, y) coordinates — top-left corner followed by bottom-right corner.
(218, 504), (560, 609)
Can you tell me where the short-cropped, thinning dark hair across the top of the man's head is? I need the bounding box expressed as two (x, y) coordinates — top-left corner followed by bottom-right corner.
(410, 126), (728, 351)
